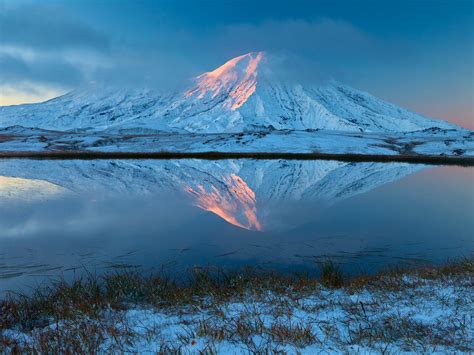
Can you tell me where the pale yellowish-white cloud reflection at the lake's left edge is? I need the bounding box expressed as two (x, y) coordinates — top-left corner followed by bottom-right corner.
(0, 176), (68, 203)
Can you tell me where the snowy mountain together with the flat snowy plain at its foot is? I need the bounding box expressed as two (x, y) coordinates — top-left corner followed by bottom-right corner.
(0, 52), (474, 161)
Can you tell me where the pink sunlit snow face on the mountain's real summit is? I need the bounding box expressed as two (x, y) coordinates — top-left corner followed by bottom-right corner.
(185, 52), (264, 111)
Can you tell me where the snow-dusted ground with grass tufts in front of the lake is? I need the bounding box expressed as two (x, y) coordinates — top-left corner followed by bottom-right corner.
(0, 261), (474, 354)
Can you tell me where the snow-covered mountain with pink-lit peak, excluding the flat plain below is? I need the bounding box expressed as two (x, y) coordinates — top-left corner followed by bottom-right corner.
(0, 52), (458, 133)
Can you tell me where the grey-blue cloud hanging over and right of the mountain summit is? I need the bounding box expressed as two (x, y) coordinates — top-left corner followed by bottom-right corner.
(209, 19), (379, 82)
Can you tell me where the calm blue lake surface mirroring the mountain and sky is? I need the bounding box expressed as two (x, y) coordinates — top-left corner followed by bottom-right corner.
(0, 159), (474, 293)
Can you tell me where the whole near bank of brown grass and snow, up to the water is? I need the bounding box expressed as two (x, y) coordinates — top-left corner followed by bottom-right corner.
(0, 258), (474, 353)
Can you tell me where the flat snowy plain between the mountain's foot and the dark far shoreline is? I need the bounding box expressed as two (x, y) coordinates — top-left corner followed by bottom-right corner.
(0, 126), (474, 157)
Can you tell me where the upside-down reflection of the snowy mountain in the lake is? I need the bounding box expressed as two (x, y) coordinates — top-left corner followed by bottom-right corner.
(0, 159), (424, 230)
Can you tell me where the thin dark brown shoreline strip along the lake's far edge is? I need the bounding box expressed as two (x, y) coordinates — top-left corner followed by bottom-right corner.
(0, 151), (474, 166)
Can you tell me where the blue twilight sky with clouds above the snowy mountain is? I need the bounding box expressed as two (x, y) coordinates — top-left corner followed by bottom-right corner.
(0, 0), (474, 129)
